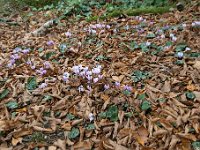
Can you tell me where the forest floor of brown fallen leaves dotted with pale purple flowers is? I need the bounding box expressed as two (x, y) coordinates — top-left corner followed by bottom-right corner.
(0, 2), (200, 150)
